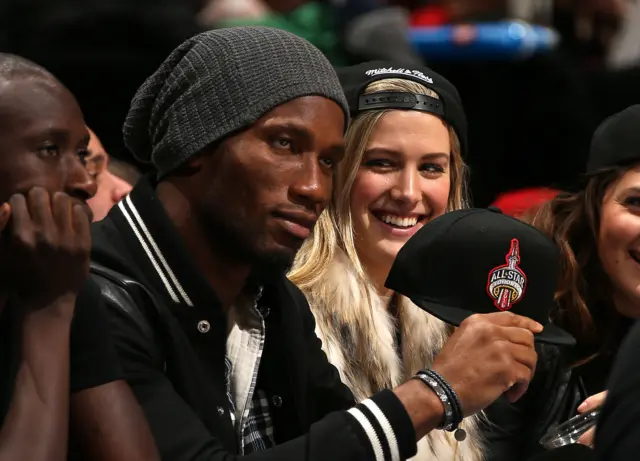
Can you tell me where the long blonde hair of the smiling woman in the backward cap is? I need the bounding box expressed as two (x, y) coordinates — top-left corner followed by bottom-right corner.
(289, 78), (468, 290)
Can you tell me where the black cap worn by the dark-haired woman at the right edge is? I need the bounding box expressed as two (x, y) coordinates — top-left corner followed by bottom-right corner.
(587, 105), (640, 175)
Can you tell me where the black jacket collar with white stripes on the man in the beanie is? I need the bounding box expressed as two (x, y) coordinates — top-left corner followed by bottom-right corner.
(105, 178), (320, 428)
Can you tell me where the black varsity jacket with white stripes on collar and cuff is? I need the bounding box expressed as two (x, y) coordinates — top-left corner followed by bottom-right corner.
(82, 179), (416, 461)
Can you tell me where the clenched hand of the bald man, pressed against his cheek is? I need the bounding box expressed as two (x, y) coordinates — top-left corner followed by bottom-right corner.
(0, 187), (91, 303)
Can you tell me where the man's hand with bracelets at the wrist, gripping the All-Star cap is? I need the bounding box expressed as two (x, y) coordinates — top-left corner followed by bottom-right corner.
(432, 312), (543, 416)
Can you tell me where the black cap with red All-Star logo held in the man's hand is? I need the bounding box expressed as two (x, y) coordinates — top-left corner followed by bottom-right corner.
(386, 207), (575, 346)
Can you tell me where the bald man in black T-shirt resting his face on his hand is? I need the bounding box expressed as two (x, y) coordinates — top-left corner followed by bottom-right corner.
(0, 53), (158, 461)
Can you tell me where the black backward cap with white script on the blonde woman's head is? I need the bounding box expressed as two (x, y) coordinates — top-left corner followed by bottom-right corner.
(336, 61), (467, 155)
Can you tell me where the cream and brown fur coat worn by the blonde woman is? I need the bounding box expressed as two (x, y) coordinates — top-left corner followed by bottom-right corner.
(305, 252), (483, 461)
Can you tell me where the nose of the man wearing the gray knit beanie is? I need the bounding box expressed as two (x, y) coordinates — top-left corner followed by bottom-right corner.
(290, 156), (333, 214)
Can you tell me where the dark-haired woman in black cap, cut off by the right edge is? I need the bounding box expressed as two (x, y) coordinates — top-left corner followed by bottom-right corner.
(526, 106), (640, 445)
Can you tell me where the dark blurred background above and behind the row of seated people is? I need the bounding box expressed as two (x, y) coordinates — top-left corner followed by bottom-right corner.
(0, 0), (640, 206)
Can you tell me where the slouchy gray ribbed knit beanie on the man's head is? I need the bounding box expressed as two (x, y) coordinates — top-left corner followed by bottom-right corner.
(123, 27), (349, 177)
